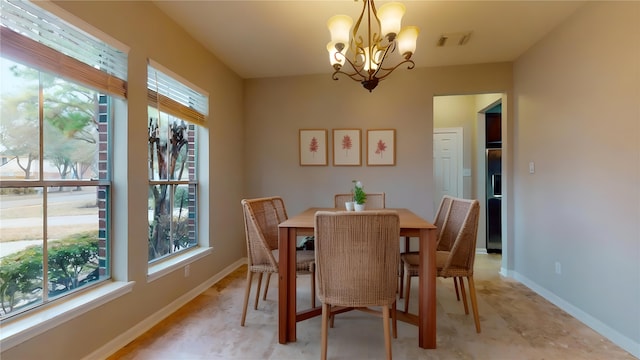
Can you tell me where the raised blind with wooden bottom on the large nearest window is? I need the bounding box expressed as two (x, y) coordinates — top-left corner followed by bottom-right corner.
(0, 0), (127, 97)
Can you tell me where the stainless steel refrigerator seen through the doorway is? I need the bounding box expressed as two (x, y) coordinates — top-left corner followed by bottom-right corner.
(486, 149), (502, 253)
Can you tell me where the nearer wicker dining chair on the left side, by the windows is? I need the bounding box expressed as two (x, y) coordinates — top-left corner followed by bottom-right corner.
(240, 196), (316, 326)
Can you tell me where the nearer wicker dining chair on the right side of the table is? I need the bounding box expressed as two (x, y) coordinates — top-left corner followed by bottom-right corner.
(402, 198), (480, 333)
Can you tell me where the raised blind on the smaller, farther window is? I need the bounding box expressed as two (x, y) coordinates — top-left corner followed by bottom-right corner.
(147, 64), (209, 124)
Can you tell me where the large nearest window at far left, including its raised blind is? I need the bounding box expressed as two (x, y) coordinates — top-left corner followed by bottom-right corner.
(0, 0), (126, 319)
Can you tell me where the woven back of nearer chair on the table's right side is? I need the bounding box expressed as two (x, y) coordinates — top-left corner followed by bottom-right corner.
(441, 198), (480, 276)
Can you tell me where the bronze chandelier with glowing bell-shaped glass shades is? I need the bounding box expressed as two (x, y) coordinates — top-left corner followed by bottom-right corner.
(327, 0), (419, 92)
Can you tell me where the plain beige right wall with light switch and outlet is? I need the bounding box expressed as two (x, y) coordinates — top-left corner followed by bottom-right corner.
(513, 2), (640, 356)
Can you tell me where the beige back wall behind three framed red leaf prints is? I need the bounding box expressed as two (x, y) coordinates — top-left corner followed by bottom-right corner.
(245, 63), (512, 219)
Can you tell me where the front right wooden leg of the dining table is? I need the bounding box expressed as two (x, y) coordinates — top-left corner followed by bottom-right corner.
(418, 229), (437, 349)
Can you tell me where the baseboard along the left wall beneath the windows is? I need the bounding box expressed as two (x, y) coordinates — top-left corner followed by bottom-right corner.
(83, 258), (247, 360)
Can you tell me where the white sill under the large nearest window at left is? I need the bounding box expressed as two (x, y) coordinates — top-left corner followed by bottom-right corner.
(0, 281), (135, 350)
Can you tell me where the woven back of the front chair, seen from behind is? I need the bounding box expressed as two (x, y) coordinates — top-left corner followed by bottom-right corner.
(315, 210), (400, 307)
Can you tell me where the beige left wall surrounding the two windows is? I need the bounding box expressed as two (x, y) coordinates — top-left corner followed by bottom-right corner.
(0, 1), (245, 359)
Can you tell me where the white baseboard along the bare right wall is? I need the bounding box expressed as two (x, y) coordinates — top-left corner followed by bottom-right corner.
(510, 269), (640, 359)
